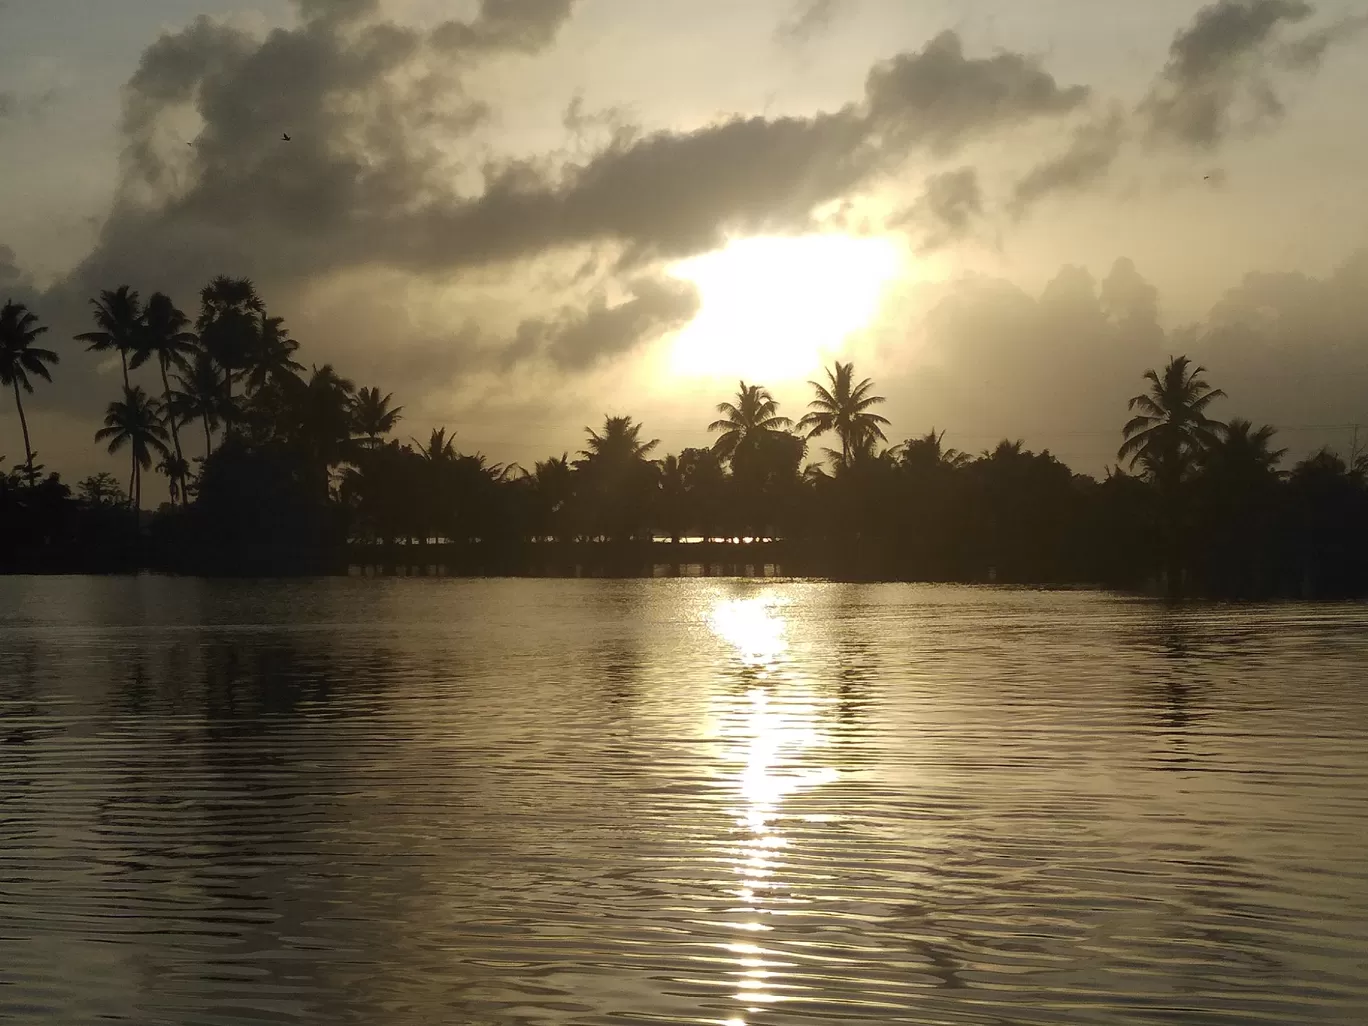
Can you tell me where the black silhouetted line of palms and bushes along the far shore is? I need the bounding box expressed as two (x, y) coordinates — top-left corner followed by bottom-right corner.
(0, 278), (1368, 598)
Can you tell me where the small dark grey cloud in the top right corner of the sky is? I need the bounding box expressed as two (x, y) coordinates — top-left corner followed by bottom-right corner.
(1138, 0), (1358, 148)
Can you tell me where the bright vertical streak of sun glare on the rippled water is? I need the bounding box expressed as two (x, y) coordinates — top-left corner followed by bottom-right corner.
(709, 594), (840, 1026)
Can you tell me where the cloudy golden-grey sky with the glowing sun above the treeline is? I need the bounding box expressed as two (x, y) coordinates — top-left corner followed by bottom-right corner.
(0, 0), (1368, 497)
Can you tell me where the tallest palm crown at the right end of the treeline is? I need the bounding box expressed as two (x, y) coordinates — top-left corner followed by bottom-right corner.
(1116, 356), (1226, 494)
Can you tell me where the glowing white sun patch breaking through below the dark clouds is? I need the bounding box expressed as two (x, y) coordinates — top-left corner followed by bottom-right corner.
(669, 235), (904, 382)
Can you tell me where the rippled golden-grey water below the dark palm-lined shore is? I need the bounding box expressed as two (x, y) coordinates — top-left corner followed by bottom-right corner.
(0, 577), (1368, 1026)
